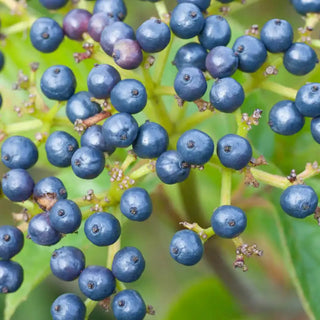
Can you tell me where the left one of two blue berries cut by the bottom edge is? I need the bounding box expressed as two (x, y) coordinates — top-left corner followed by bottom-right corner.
(51, 293), (86, 320)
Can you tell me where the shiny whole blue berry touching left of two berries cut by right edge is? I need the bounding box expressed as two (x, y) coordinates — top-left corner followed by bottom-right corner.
(268, 100), (305, 136)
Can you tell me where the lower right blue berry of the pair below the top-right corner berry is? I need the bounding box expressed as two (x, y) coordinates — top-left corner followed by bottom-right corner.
(283, 42), (318, 76)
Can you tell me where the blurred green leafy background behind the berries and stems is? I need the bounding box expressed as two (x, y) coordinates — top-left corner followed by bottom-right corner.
(0, 0), (320, 320)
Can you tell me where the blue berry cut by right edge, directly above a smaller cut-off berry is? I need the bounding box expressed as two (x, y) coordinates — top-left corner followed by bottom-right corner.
(295, 82), (320, 118)
